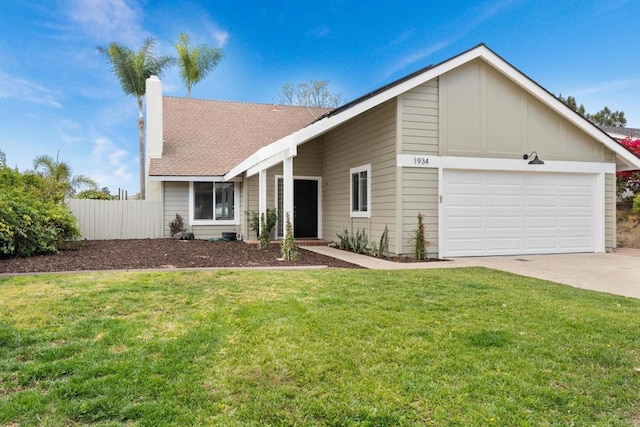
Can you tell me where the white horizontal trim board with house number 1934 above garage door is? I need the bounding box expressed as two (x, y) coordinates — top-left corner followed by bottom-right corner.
(396, 154), (616, 173)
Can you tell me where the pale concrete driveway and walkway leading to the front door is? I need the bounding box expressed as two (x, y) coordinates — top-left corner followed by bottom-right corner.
(304, 246), (640, 298)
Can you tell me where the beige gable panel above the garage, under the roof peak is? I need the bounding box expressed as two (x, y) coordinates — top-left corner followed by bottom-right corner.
(440, 60), (604, 162)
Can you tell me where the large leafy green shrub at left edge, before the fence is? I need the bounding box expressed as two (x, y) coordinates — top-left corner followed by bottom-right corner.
(0, 167), (80, 257)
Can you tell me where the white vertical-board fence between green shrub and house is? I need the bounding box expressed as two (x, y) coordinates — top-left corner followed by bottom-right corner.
(67, 199), (164, 240)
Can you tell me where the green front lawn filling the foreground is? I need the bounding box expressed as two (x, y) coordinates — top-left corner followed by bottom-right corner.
(0, 268), (640, 426)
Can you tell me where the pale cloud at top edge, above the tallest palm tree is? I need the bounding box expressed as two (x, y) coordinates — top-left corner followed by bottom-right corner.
(68, 0), (148, 44)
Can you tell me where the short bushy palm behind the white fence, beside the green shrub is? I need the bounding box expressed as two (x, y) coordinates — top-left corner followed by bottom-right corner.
(33, 154), (98, 201)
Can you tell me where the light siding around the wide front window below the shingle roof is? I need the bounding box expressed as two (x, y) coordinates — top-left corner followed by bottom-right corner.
(164, 182), (244, 239)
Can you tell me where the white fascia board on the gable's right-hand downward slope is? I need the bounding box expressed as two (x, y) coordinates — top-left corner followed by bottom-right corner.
(480, 46), (640, 169)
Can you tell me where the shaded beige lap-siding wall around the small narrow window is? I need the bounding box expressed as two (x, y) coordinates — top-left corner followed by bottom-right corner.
(322, 100), (397, 252)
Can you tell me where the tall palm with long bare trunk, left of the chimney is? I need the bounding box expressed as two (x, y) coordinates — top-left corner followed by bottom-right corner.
(98, 38), (175, 200)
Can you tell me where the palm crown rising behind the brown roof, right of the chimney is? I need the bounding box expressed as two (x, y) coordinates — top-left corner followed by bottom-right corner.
(175, 33), (224, 98)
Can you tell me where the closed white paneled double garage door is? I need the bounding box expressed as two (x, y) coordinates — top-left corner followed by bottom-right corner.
(440, 170), (598, 257)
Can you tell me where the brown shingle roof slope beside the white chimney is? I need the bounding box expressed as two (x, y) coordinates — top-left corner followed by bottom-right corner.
(149, 96), (330, 176)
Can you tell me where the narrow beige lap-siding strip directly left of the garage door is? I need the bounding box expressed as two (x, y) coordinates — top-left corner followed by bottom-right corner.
(398, 79), (440, 257)
